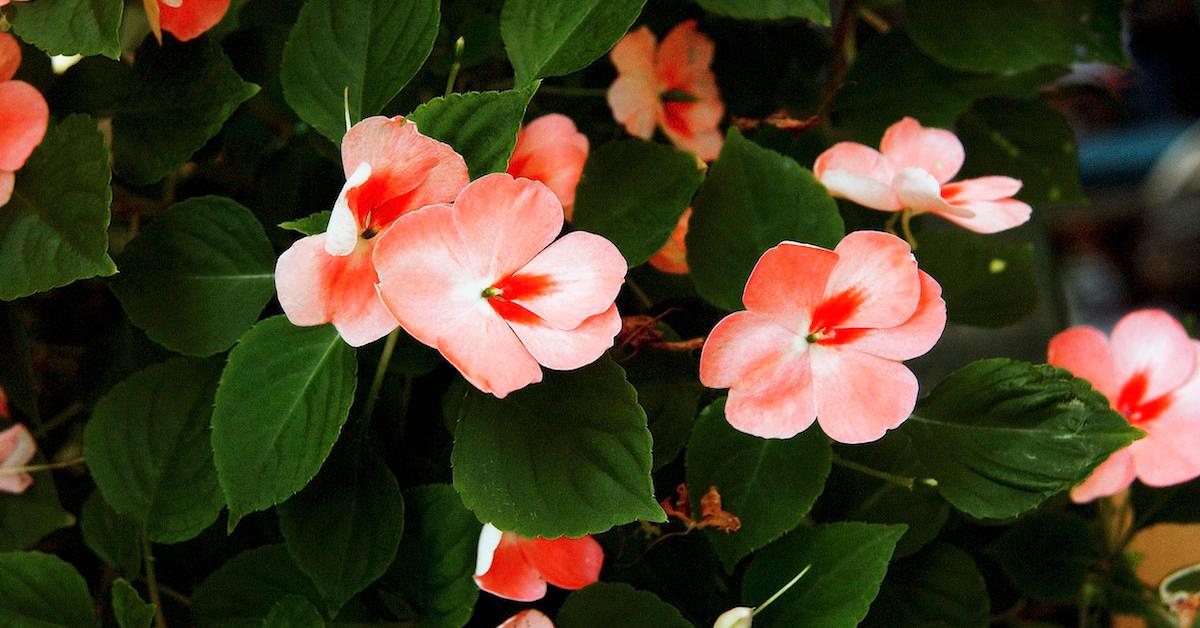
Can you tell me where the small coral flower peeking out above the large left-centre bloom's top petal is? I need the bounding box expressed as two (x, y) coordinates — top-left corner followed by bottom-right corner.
(509, 113), (588, 220)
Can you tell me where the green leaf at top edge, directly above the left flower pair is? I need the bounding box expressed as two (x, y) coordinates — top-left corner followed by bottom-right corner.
(280, 0), (442, 144)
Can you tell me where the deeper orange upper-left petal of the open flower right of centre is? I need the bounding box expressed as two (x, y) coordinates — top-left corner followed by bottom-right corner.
(742, 243), (838, 334)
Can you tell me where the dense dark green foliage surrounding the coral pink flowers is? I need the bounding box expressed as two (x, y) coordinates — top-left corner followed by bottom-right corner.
(0, 0), (1200, 628)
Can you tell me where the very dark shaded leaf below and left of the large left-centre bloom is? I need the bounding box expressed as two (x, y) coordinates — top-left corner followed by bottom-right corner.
(278, 447), (404, 615)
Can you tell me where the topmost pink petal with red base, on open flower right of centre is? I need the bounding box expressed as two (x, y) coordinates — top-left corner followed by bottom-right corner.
(823, 231), (920, 328)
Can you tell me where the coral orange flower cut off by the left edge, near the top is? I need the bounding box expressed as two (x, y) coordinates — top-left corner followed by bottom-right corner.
(0, 32), (50, 205)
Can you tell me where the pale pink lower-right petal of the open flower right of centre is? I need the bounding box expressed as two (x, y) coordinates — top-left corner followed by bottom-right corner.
(810, 346), (917, 444)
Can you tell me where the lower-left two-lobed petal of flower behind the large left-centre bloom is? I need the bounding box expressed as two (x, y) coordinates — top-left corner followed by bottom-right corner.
(275, 234), (396, 347)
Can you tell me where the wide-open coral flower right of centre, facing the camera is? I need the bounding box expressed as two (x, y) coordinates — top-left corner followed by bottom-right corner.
(700, 232), (946, 443)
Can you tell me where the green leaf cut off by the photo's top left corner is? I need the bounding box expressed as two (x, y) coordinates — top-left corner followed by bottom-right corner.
(7, 0), (125, 59)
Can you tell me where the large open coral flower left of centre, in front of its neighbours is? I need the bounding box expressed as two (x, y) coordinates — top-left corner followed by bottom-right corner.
(374, 173), (626, 397)
